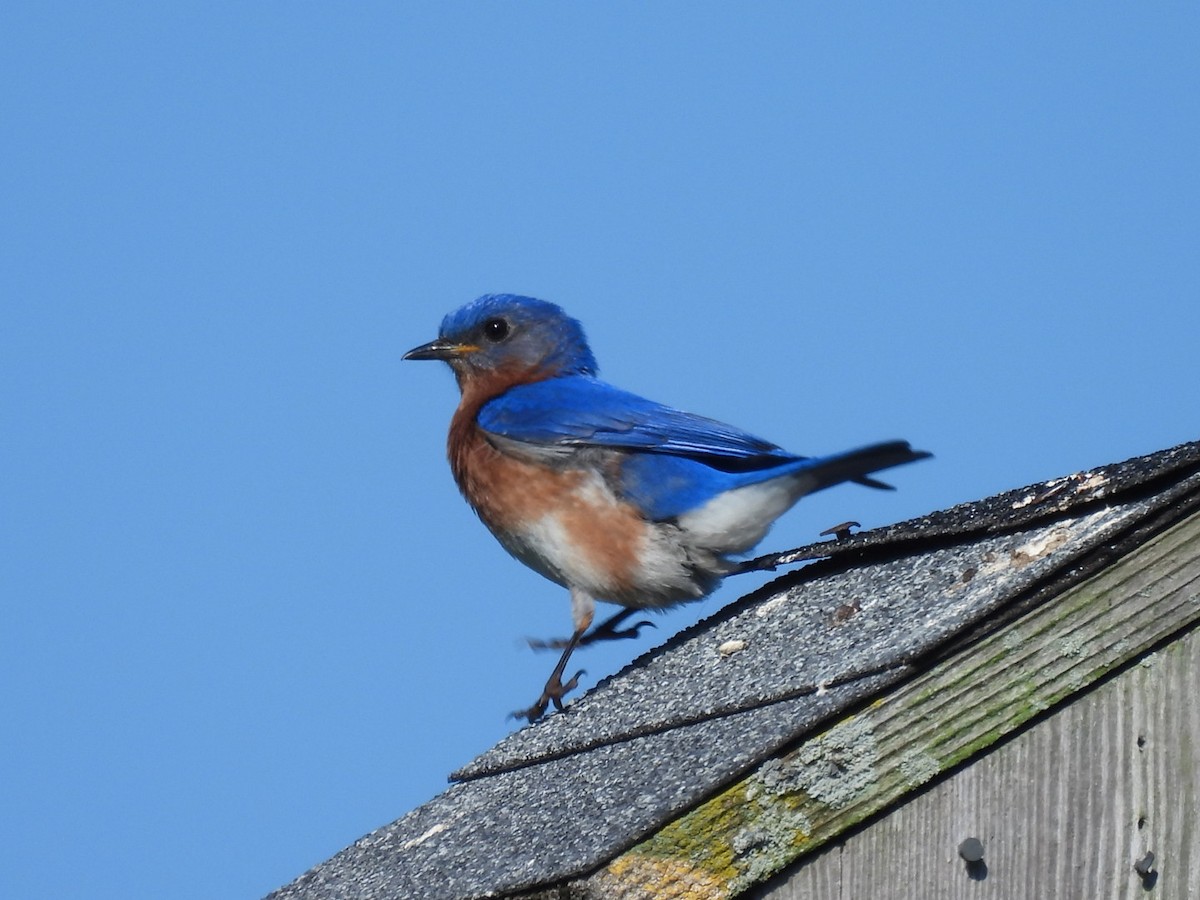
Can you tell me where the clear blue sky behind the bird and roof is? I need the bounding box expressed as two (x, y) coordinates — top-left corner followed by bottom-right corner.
(0, 1), (1200, 898)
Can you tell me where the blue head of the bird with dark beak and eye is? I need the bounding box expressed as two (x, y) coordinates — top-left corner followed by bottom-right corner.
(404, 294), (596, 386)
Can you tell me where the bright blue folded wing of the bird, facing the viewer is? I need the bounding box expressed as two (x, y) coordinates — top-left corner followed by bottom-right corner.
(478, 376), (802, 470)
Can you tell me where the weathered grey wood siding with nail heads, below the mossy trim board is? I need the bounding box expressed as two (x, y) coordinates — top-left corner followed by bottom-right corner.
(744, 630), (1200, 900)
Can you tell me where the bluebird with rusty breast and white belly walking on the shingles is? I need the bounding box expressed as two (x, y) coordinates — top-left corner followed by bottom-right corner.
(403, 294), (930, 722)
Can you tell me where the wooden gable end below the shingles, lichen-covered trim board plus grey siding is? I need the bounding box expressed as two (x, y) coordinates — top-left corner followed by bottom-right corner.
(571, 515), (1200, 900)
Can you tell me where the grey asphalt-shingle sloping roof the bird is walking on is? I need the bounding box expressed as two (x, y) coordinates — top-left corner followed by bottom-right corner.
(271, 442), (1200, 900)
